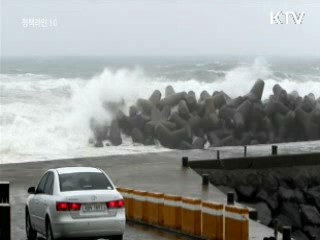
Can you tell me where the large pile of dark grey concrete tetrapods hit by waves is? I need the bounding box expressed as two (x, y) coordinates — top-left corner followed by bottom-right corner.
(90, 79), (320, 149)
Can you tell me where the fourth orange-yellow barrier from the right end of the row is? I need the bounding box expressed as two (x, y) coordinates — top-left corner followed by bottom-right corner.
(163, 194), (181, 230)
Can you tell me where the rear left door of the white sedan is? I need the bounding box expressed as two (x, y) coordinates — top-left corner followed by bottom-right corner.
(38, 172), (54, 233)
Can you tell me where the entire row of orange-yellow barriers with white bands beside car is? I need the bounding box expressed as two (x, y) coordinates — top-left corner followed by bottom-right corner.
(117, 188), (249, 240)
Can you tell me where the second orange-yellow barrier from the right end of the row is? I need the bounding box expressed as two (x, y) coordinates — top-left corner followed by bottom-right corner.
(201, 201), (224, 240)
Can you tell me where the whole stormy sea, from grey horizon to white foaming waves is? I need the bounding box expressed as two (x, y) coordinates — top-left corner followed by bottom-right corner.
(0, 57), (320, 163)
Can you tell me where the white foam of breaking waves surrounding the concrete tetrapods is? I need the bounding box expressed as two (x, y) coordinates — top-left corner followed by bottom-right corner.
(0, 59), (320, 163)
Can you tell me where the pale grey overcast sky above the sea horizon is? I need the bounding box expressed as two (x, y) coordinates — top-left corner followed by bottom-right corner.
(1, 0), (320, 56)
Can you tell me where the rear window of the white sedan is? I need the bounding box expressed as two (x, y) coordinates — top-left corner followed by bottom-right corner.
(59, 172), (113, 192)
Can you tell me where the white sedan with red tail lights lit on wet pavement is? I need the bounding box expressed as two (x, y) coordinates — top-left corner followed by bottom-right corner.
(25, 167), (126, 240)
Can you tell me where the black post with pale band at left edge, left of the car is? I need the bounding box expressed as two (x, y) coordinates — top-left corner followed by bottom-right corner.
(0, 182), (11, 240)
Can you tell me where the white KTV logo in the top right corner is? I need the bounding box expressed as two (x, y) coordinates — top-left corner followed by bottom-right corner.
(270, 11), (305, 25)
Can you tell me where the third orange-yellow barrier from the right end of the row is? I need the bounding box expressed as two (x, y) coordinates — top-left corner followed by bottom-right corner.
(181, 198), (201, 236)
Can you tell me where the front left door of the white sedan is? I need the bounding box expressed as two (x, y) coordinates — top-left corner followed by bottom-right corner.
(29, 173), (48, 232)
